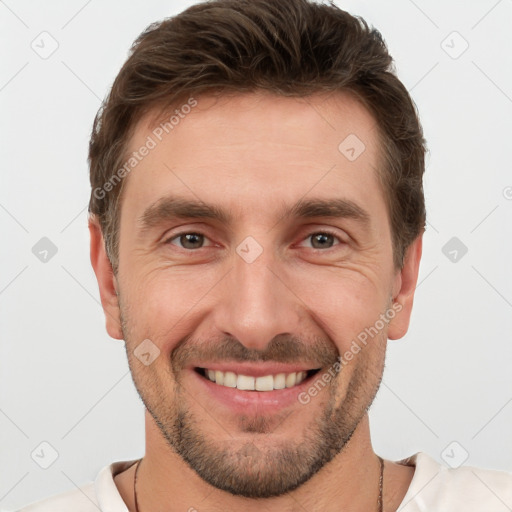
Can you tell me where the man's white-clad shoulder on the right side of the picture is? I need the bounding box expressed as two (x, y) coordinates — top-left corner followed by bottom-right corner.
(398, 452), (512, 512)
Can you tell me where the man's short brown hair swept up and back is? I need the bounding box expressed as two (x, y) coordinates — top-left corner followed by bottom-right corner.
(89, 0), (426, 273)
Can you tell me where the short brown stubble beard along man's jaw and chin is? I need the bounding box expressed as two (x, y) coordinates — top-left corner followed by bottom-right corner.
(121, 304), (384, 499)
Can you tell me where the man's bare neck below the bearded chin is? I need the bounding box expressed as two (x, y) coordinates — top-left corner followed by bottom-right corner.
(134, 413), (387, 512)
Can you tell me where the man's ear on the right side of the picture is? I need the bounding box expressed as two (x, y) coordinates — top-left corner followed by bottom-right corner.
(388, 233), (423, 340)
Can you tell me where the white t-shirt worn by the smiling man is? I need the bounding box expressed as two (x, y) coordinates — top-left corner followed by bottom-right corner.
(19, 452), (512, 512)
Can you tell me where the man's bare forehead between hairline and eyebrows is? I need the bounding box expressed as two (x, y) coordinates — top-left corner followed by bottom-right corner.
(122, 93), (384, 226)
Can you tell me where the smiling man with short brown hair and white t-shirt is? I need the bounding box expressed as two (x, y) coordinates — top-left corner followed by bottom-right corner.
(20, 0), (512, 512)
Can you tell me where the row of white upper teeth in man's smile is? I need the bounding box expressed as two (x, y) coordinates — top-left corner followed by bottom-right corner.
(205, 370), (307, 391)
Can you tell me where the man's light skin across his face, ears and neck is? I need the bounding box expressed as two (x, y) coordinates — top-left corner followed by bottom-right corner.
(89, 93), (422, 512)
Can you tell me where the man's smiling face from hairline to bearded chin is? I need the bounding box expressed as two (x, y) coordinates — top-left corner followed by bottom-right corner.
(94, 93), (418, 498)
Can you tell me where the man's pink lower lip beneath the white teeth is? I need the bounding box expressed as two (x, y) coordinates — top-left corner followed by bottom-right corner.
(191, 370), (317, 414)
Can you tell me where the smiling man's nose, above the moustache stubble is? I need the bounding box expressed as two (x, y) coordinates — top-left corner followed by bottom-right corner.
(214, 243), (303, 350)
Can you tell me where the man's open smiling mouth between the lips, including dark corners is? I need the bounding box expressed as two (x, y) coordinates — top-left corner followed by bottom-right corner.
(194, 367), (320, 392)
